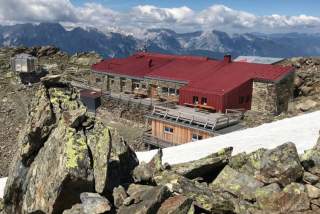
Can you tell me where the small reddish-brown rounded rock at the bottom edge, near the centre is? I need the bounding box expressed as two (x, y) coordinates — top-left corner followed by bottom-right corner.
(157, 195), (193, 214)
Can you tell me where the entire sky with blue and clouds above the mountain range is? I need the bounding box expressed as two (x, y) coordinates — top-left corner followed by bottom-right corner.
(0, 0), (320, 35)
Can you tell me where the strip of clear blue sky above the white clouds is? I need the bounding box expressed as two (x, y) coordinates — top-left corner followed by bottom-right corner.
(73, 0), (320, 16)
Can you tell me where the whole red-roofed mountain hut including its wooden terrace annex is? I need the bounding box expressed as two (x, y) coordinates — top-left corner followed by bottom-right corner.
(92, 52), (295, 144)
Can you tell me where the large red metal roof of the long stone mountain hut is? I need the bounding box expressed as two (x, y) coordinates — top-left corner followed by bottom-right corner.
(93, 53), (293, 94)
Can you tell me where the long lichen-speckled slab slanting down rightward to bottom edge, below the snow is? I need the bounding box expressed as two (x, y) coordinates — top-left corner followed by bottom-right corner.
(154, 171), (234, 213)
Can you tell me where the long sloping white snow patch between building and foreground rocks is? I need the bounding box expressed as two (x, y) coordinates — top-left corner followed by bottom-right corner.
(137, 111), (320, 164)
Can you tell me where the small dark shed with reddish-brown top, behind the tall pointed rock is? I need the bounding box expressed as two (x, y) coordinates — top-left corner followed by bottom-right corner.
(80, 89), (101, 112)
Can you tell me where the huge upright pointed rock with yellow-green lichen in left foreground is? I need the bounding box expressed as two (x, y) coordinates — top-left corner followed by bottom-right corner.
(4, 76), (125, 213)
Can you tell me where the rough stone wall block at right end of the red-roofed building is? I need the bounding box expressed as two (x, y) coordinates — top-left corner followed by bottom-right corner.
(251, 73), (295, 115)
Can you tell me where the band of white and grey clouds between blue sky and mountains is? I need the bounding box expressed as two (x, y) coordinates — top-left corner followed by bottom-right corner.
(0, 0), (320, 32)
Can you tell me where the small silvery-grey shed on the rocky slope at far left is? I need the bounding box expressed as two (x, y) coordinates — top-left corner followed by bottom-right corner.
(11, 53), (38, 73)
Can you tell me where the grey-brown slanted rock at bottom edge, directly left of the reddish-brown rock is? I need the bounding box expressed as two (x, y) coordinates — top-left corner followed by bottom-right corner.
(118, 185), (171, 214)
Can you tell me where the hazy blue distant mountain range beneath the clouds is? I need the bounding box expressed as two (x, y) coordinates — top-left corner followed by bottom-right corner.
(0, 23), (320, 58)
